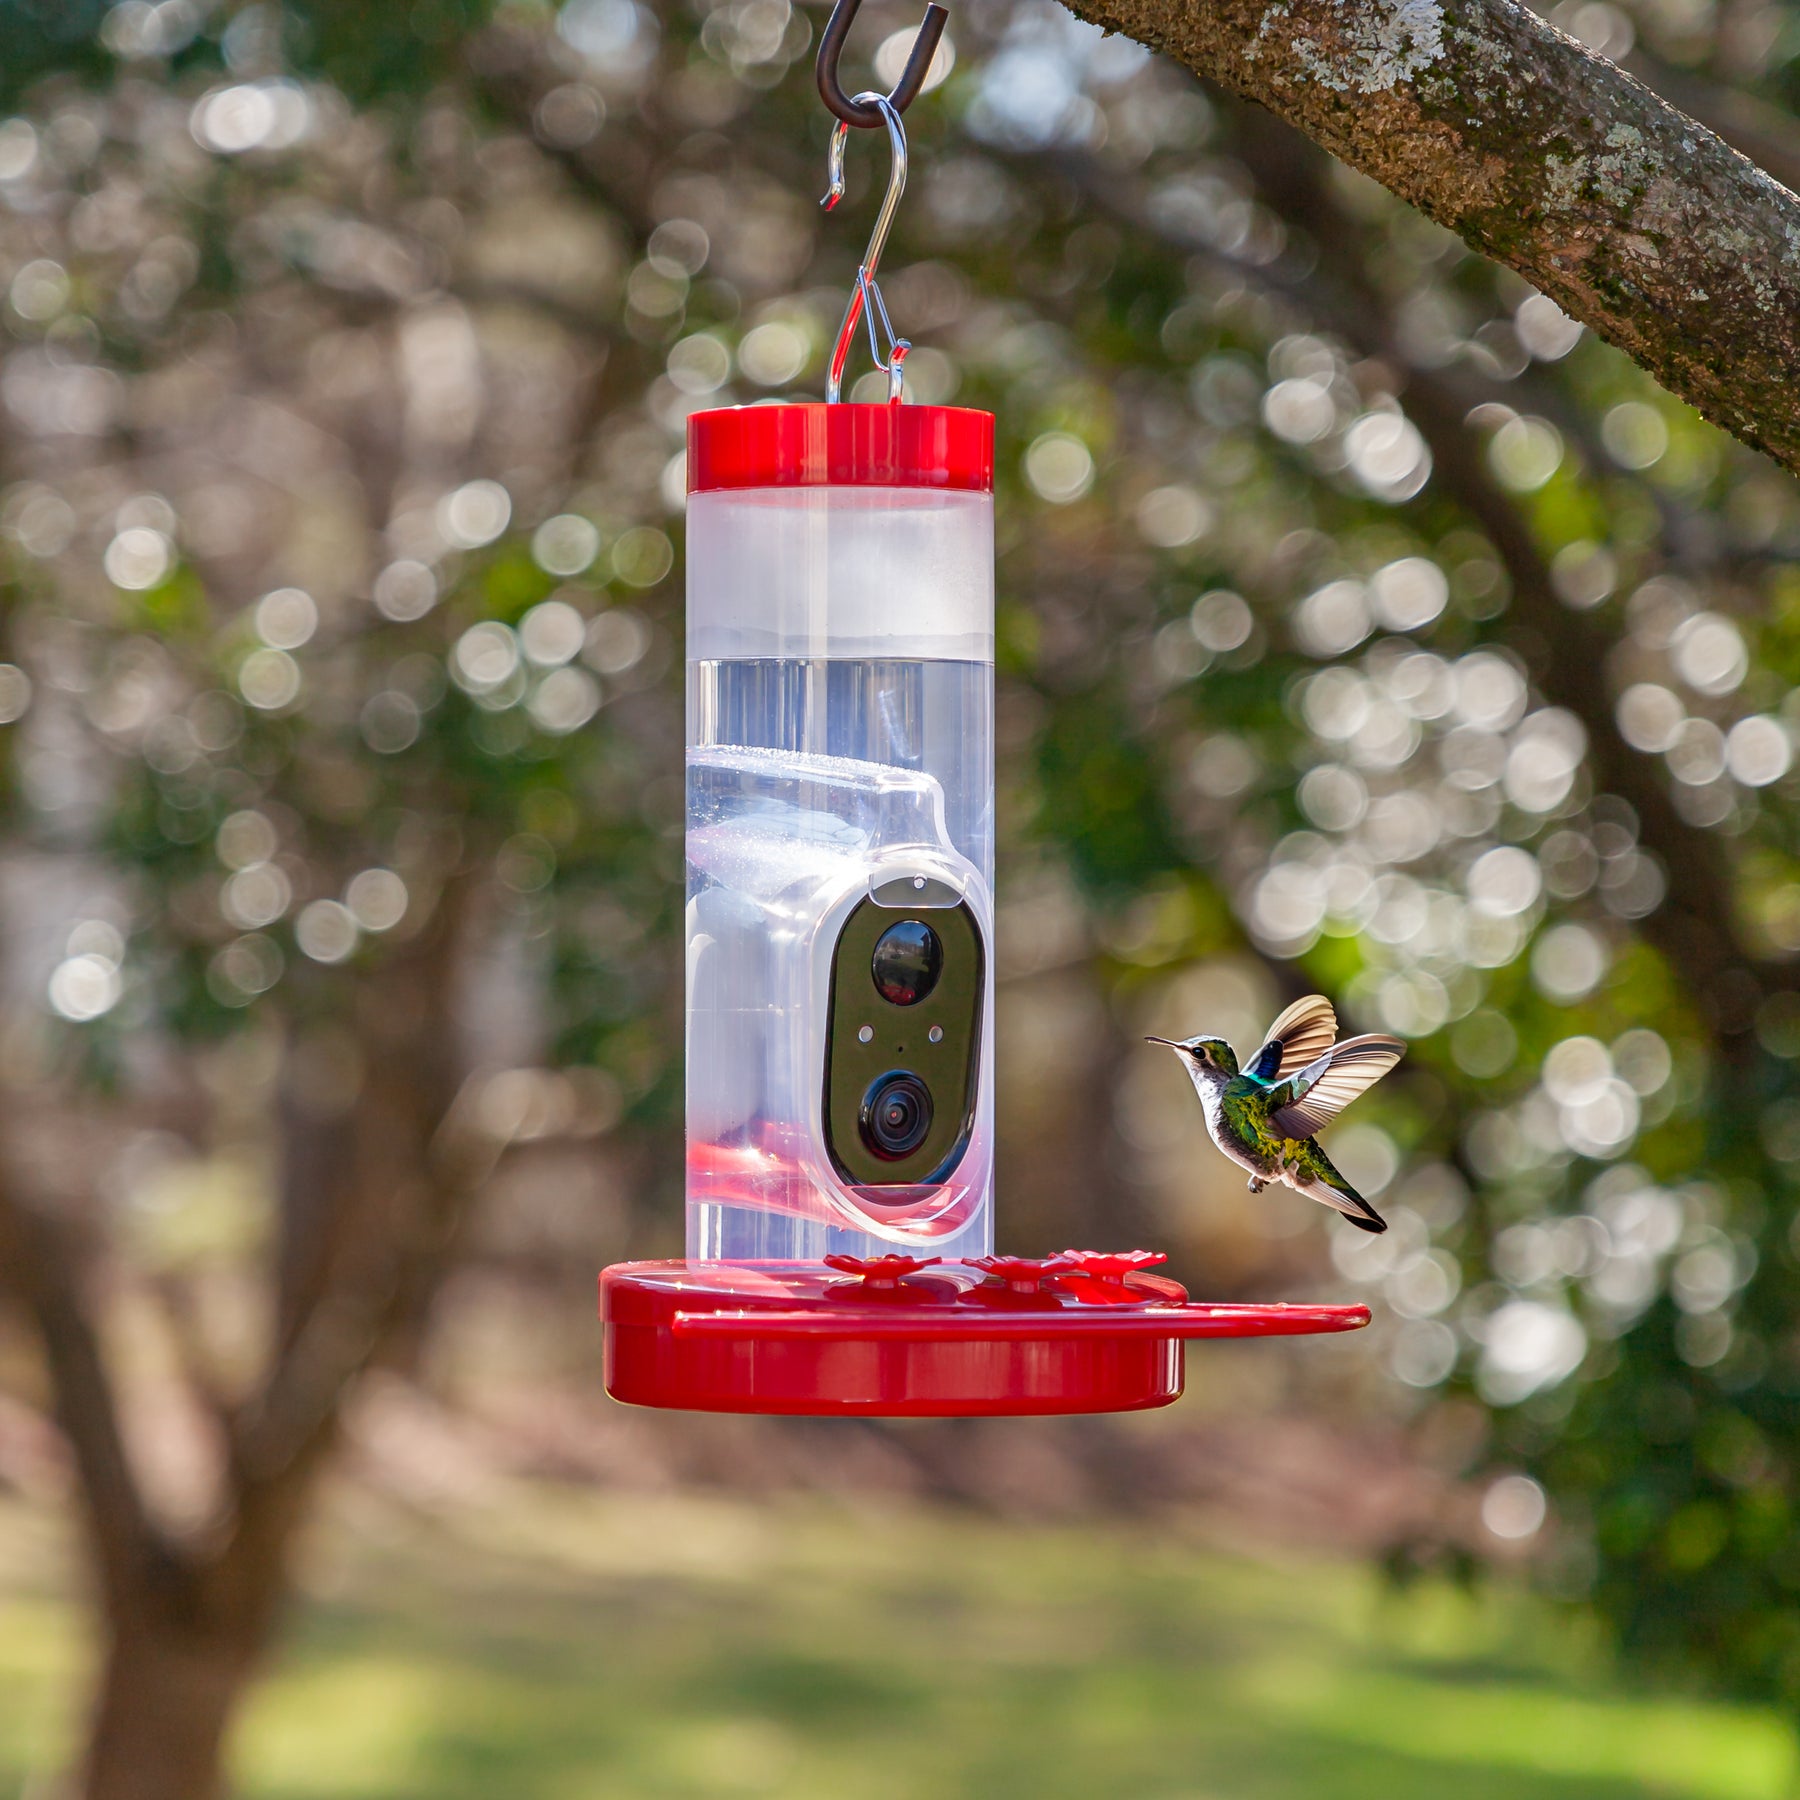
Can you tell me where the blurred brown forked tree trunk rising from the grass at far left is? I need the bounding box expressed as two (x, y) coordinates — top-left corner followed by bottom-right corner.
(0, 864), (491, 1800)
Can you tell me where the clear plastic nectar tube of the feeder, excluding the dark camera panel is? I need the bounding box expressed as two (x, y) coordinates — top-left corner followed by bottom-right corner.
(688, 488), (994, 1260)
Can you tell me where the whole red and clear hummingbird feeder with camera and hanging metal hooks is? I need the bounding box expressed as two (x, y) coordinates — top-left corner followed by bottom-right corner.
(599, 0), (1368, 1415)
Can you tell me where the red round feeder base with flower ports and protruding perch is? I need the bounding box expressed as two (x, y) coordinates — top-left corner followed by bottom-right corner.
(599, 1251), (1368, 1418)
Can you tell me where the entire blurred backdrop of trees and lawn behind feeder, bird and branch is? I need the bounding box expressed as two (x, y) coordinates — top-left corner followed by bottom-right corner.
(0, 0), (1800, 1800)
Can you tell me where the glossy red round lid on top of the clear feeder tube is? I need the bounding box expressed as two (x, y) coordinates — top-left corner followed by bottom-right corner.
(688, 403), (994, 493)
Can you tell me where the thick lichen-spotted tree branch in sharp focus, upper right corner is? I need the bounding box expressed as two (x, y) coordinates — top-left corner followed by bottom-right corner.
(1066, 0), (1800, 470)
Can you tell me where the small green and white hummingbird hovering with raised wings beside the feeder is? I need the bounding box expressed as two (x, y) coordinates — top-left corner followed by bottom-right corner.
(1147, 994), (1406, 1231)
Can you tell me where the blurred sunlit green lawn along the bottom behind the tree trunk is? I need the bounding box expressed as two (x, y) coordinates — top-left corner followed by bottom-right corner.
(0, 1489), (1800, 1800)
